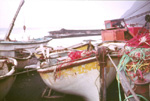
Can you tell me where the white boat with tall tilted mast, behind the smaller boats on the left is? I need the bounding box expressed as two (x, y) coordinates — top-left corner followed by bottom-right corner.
(0, 0), (52, 70)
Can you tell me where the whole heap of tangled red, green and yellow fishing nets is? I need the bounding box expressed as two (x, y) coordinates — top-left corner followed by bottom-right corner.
(117, 30), (150, 101)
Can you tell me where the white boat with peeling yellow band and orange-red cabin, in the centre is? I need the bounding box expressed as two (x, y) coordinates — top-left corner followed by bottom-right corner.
(26, 16), (136, 101)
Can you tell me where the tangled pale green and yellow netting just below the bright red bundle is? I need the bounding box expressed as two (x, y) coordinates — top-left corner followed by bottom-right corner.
(118, 46), (150, 74)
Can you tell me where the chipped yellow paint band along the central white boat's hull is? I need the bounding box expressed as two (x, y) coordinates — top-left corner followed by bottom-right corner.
(40, 58), (119, 79)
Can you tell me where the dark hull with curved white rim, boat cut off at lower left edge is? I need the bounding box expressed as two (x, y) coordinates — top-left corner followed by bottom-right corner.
(0, 58), (17, 101)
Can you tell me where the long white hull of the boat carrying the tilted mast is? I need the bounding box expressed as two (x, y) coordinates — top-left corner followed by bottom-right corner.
(0, 38), (51, 57)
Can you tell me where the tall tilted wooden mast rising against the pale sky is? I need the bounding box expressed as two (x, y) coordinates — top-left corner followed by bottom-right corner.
(4, 0), (25, 41)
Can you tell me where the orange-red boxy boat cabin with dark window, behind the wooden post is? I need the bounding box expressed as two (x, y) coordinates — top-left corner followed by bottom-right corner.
(101, 19), (134, 41)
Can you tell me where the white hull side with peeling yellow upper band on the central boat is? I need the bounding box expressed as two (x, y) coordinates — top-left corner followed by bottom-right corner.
(38, 57), (119, 101)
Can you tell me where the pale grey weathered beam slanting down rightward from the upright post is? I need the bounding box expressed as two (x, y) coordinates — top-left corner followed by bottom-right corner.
(107, 54), (140, 101)
